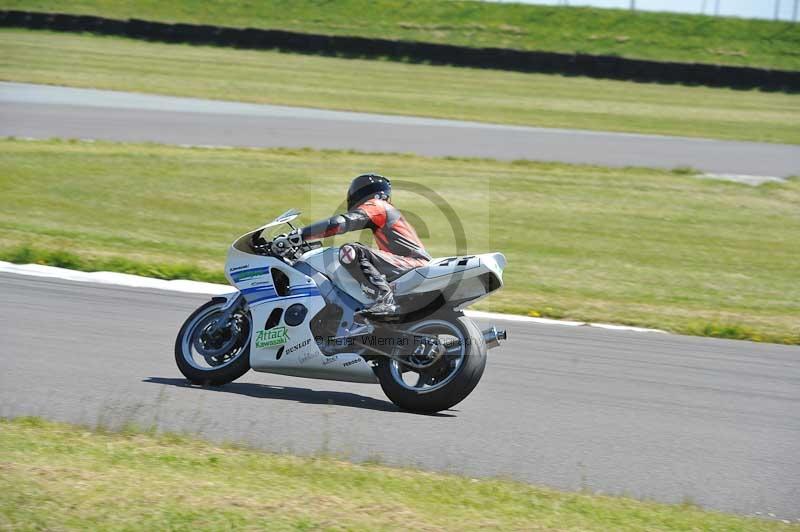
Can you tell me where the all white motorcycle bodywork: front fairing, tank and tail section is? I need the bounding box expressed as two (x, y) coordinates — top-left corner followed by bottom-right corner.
(225, 227), (505, 383)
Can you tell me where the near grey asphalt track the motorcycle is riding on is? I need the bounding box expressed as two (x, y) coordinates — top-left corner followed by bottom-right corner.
(0, 274), (800, 520)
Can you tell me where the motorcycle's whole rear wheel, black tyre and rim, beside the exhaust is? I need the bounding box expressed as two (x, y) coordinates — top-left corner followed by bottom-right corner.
(376, 315), (486, 414)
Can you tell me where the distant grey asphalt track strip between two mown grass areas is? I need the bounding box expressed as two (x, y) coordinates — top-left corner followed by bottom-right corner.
(0, 83), (800, 177)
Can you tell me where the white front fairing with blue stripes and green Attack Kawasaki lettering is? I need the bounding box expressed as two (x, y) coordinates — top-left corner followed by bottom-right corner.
(225, 234), (377, 383)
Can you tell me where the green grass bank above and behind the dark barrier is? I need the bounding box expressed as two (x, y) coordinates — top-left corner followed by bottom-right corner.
(0, 0), (800, 70)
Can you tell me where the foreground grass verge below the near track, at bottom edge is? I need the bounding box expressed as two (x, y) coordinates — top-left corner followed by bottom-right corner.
(0, 418), (800, 532)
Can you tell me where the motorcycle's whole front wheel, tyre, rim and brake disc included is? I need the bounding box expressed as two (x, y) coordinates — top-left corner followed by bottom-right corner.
(175, 300), (252, 386)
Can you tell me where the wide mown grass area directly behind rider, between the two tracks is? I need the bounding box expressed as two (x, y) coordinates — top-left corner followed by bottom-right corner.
(0, 140), (800, 343)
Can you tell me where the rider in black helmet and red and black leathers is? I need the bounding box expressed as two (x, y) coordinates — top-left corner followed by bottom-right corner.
(287, 174), (431, 316)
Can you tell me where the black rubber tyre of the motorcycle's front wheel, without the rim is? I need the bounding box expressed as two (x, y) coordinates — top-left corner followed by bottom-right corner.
(175, 300), (252, 386)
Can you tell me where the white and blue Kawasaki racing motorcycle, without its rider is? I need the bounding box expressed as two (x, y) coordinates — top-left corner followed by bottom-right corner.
(175, 209), (506, 413)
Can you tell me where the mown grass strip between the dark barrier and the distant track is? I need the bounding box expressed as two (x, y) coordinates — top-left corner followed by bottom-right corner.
(0, 30), (800, 143)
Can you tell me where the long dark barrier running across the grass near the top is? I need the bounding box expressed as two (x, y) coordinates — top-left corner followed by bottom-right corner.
(0, 10), (800, 92)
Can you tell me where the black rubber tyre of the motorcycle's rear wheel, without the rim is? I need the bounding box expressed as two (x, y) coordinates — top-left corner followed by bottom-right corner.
(375, 314), (486, 414)
